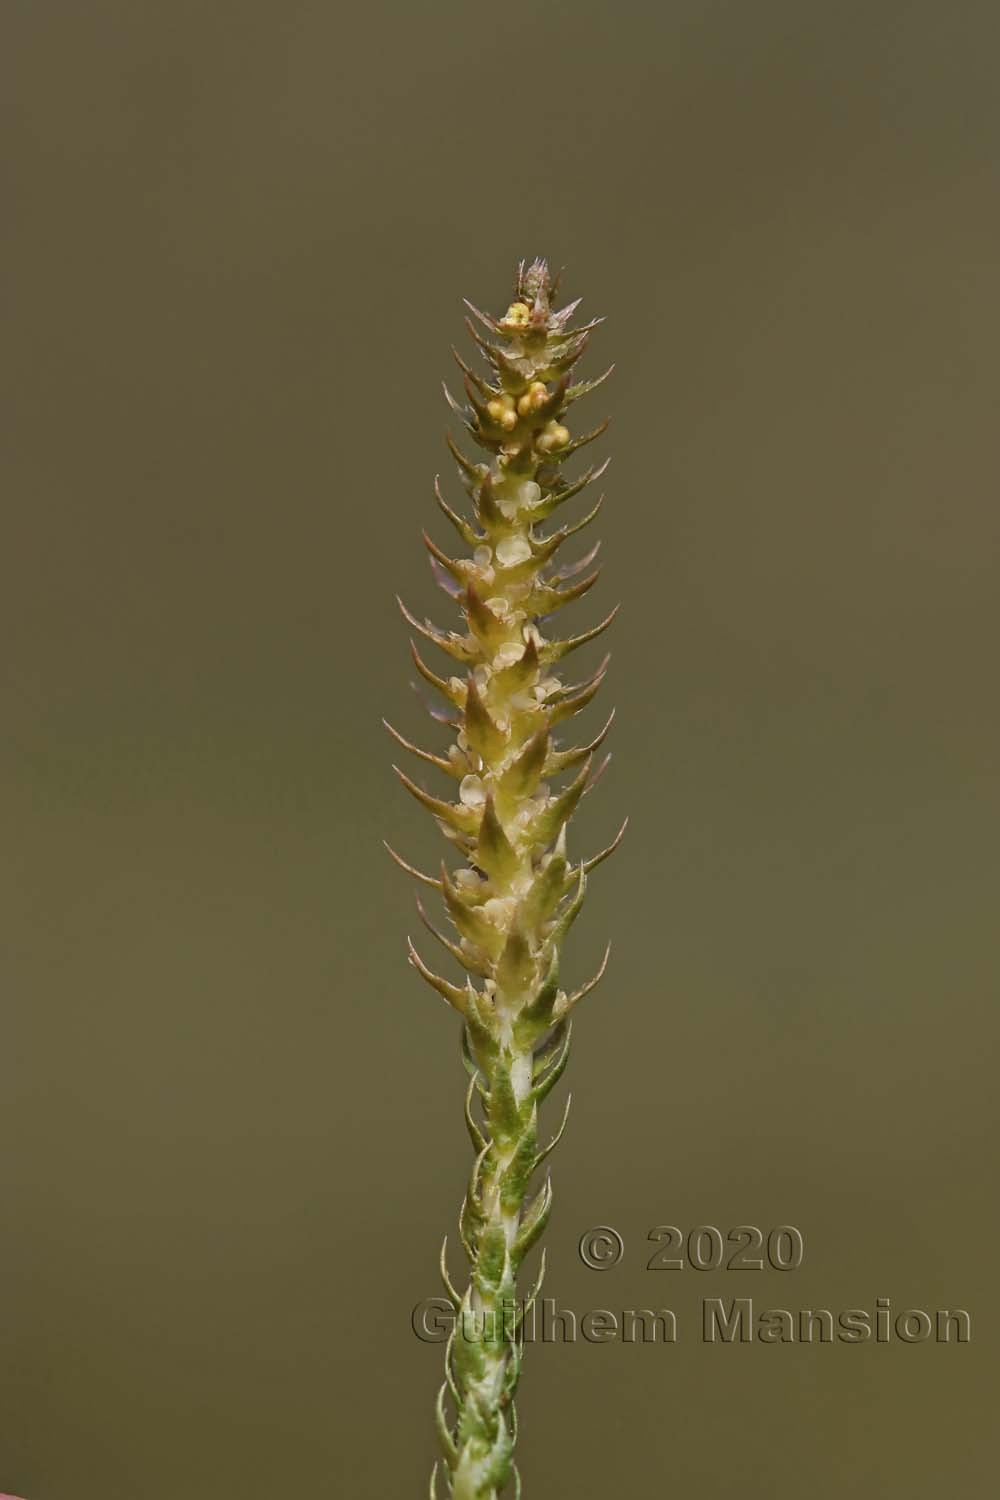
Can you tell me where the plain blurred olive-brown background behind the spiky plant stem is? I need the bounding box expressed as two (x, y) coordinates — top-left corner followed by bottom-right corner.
(0, 0), (1000, 1500)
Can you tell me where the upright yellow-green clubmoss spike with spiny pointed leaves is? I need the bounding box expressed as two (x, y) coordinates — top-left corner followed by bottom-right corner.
(387, 261), (624, 1500)
